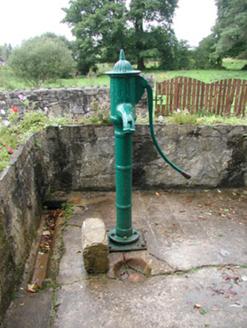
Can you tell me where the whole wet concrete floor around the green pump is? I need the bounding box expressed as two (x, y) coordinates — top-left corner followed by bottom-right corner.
(2, 189), (247, 328)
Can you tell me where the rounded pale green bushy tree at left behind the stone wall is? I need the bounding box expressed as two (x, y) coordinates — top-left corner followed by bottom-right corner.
(8, 36), (75, 87)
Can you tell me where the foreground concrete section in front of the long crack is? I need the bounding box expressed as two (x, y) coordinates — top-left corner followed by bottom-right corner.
(54, 268), (247, 328)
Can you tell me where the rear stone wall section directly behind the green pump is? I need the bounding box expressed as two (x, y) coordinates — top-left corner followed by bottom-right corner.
(47, 124), (247, 190)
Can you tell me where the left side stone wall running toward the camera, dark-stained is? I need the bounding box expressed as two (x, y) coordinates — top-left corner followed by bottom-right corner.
(0, 133), (50, 322)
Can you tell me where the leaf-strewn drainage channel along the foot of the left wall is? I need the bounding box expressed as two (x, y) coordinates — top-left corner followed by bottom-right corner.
(26, 200), (66, 293)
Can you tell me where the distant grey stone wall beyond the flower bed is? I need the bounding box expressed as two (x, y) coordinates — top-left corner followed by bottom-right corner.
(0, 75), (154, 120)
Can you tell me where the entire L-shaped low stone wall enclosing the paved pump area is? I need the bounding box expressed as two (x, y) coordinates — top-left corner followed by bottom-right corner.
(0, 124), (247, 320)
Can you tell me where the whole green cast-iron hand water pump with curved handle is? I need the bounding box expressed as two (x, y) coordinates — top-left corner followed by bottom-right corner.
(106, 50), (190, 251)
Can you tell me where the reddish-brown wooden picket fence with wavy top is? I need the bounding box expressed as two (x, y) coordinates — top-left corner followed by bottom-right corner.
(155, 77), (247, 116)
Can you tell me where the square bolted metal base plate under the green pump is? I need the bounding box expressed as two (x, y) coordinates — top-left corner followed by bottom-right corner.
(108, 229), (147, 253)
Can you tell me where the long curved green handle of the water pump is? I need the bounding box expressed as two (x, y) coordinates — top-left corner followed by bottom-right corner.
(139, 76), (191, 179)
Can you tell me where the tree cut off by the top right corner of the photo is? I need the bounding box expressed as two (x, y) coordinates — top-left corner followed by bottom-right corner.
(212, 0), (247, 59)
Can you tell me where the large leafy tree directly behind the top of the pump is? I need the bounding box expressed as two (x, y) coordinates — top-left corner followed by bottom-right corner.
(63, 0), (178, 73)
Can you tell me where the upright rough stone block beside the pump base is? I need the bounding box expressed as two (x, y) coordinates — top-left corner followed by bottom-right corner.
(82, 218), (109, 273)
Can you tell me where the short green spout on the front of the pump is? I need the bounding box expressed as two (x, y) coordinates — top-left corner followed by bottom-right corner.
(117, 104), (135, 133)
